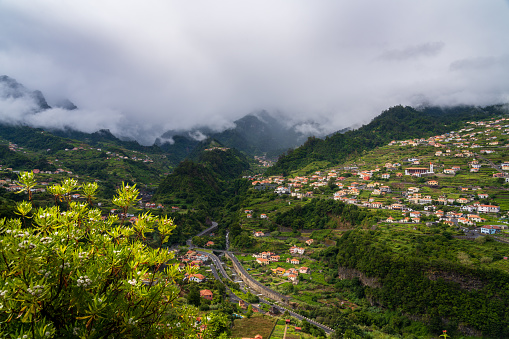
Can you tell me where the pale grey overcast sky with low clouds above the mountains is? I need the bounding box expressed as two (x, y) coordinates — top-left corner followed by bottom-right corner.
(0, 0), (509, 142)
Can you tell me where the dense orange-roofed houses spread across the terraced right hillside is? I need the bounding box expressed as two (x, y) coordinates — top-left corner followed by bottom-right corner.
(246, 119), (509, 232)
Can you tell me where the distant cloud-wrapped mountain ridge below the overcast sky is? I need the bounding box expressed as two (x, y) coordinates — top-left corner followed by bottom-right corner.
(0, 75), (338, 154)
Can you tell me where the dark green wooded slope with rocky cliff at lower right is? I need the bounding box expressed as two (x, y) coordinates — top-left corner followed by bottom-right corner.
(321, 231), (509, 337)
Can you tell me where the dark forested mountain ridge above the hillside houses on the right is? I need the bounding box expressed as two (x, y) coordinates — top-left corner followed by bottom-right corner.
(267, 105), (505, 174)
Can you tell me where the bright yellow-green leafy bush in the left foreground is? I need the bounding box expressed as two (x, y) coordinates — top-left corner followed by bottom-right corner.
(0, 173), (207, 338)
